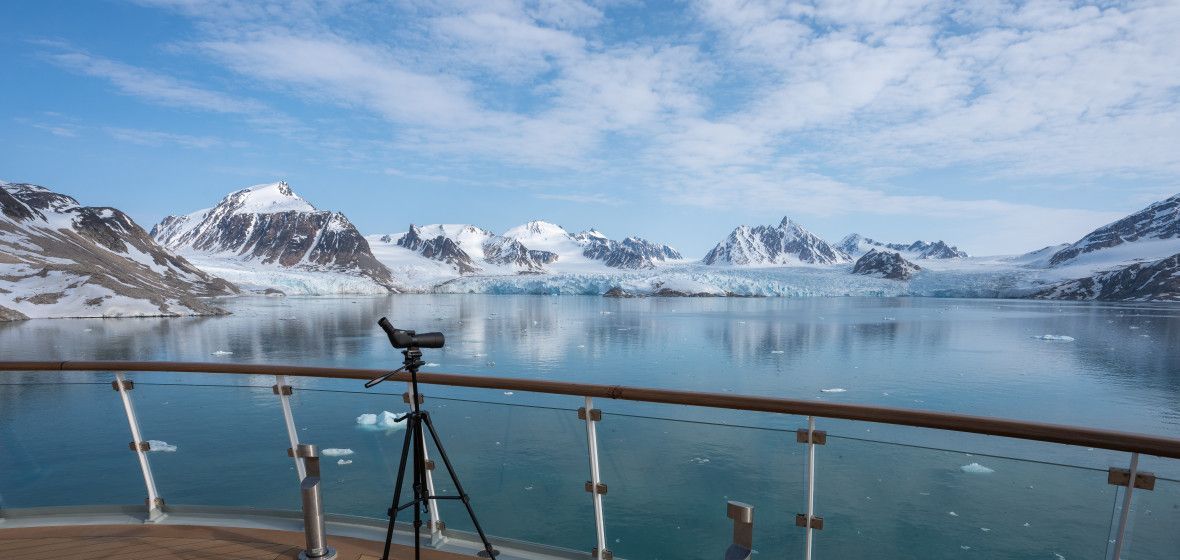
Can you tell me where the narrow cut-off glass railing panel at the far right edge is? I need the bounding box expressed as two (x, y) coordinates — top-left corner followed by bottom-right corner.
(1114, 477), (1180, 560)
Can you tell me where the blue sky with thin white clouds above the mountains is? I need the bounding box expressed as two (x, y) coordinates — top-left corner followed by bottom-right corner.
(0, 0), (1180, 256)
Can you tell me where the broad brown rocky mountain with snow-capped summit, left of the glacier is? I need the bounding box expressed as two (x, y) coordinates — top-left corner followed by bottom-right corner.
(151, 182), (398, 298)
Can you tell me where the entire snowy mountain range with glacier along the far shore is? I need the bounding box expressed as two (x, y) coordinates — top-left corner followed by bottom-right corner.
(0, 182), (1180, 319)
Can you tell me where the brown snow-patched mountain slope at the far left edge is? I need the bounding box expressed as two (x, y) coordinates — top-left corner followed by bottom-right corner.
(0, 183), (238, 319)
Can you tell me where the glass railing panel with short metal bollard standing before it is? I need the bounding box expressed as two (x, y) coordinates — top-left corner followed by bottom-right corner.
(594, 410), (806, 559)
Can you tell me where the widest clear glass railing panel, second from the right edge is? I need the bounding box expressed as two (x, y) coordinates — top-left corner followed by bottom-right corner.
(814, 434), (1117, 560)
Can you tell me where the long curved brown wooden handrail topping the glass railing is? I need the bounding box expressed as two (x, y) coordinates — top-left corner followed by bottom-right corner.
(0, 361), (1180, 459)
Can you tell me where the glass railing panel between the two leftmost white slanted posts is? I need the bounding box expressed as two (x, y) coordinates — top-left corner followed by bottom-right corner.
(133, 384), (300, 509)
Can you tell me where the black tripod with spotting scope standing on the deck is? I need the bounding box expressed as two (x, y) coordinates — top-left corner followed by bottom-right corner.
(365, 317), (499, 560)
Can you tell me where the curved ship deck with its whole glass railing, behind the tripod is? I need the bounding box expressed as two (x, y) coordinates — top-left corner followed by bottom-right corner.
(0, 362), (1180, 560)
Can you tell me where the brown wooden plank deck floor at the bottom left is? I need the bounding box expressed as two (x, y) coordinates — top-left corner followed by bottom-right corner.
(0, 525), (473, 560)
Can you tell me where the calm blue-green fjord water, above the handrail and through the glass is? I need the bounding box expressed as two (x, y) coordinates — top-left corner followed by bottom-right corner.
(0, 295), (1180, 559)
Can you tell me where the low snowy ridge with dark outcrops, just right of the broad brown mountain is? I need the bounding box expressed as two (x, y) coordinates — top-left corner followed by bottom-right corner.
(380, 224), (557, 274)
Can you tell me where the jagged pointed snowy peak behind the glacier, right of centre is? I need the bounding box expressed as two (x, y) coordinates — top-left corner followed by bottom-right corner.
(702, 218), (852, 265)
